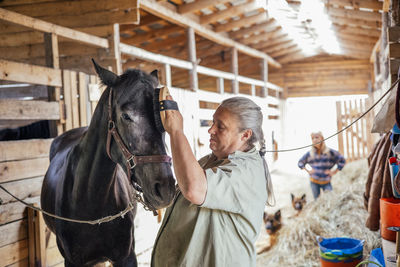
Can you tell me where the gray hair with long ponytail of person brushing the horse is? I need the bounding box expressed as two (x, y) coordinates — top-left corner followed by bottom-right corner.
(220, 96), (275, 206)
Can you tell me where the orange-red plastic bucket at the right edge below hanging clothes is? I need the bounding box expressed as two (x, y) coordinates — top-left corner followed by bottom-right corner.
(379, 198), (400, 242)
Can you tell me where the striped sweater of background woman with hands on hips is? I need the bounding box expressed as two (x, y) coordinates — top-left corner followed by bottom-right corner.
(298, 148), (346, 184)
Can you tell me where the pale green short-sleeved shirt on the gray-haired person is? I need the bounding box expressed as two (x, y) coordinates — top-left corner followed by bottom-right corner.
(151, 148), (268, 267)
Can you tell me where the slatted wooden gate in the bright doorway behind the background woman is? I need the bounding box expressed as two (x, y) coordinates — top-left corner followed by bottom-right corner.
(336, 98), (374, 162)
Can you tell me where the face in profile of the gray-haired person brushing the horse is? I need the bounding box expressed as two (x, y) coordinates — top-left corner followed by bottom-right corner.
(208, 107), (249, 159)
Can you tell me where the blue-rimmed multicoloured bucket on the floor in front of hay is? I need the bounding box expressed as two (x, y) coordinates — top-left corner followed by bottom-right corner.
(317, 236), (364, 267)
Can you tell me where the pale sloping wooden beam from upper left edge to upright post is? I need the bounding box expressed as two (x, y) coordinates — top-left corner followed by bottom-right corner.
(0, 8), (108, 48)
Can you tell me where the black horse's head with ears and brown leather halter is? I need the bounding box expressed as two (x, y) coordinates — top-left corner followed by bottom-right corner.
(94, 62), (175, 209)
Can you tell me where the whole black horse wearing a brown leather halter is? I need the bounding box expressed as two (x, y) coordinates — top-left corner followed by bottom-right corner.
(41, 62), (175, 267)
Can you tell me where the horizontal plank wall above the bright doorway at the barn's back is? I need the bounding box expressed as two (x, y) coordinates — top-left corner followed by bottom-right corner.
(269, 56), (371, 97)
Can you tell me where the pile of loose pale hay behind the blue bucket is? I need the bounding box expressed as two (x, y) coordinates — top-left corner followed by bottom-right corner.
(257, 160), (381, 267)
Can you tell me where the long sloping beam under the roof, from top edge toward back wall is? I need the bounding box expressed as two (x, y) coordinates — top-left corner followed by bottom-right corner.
(140, 0), (281, 68)
